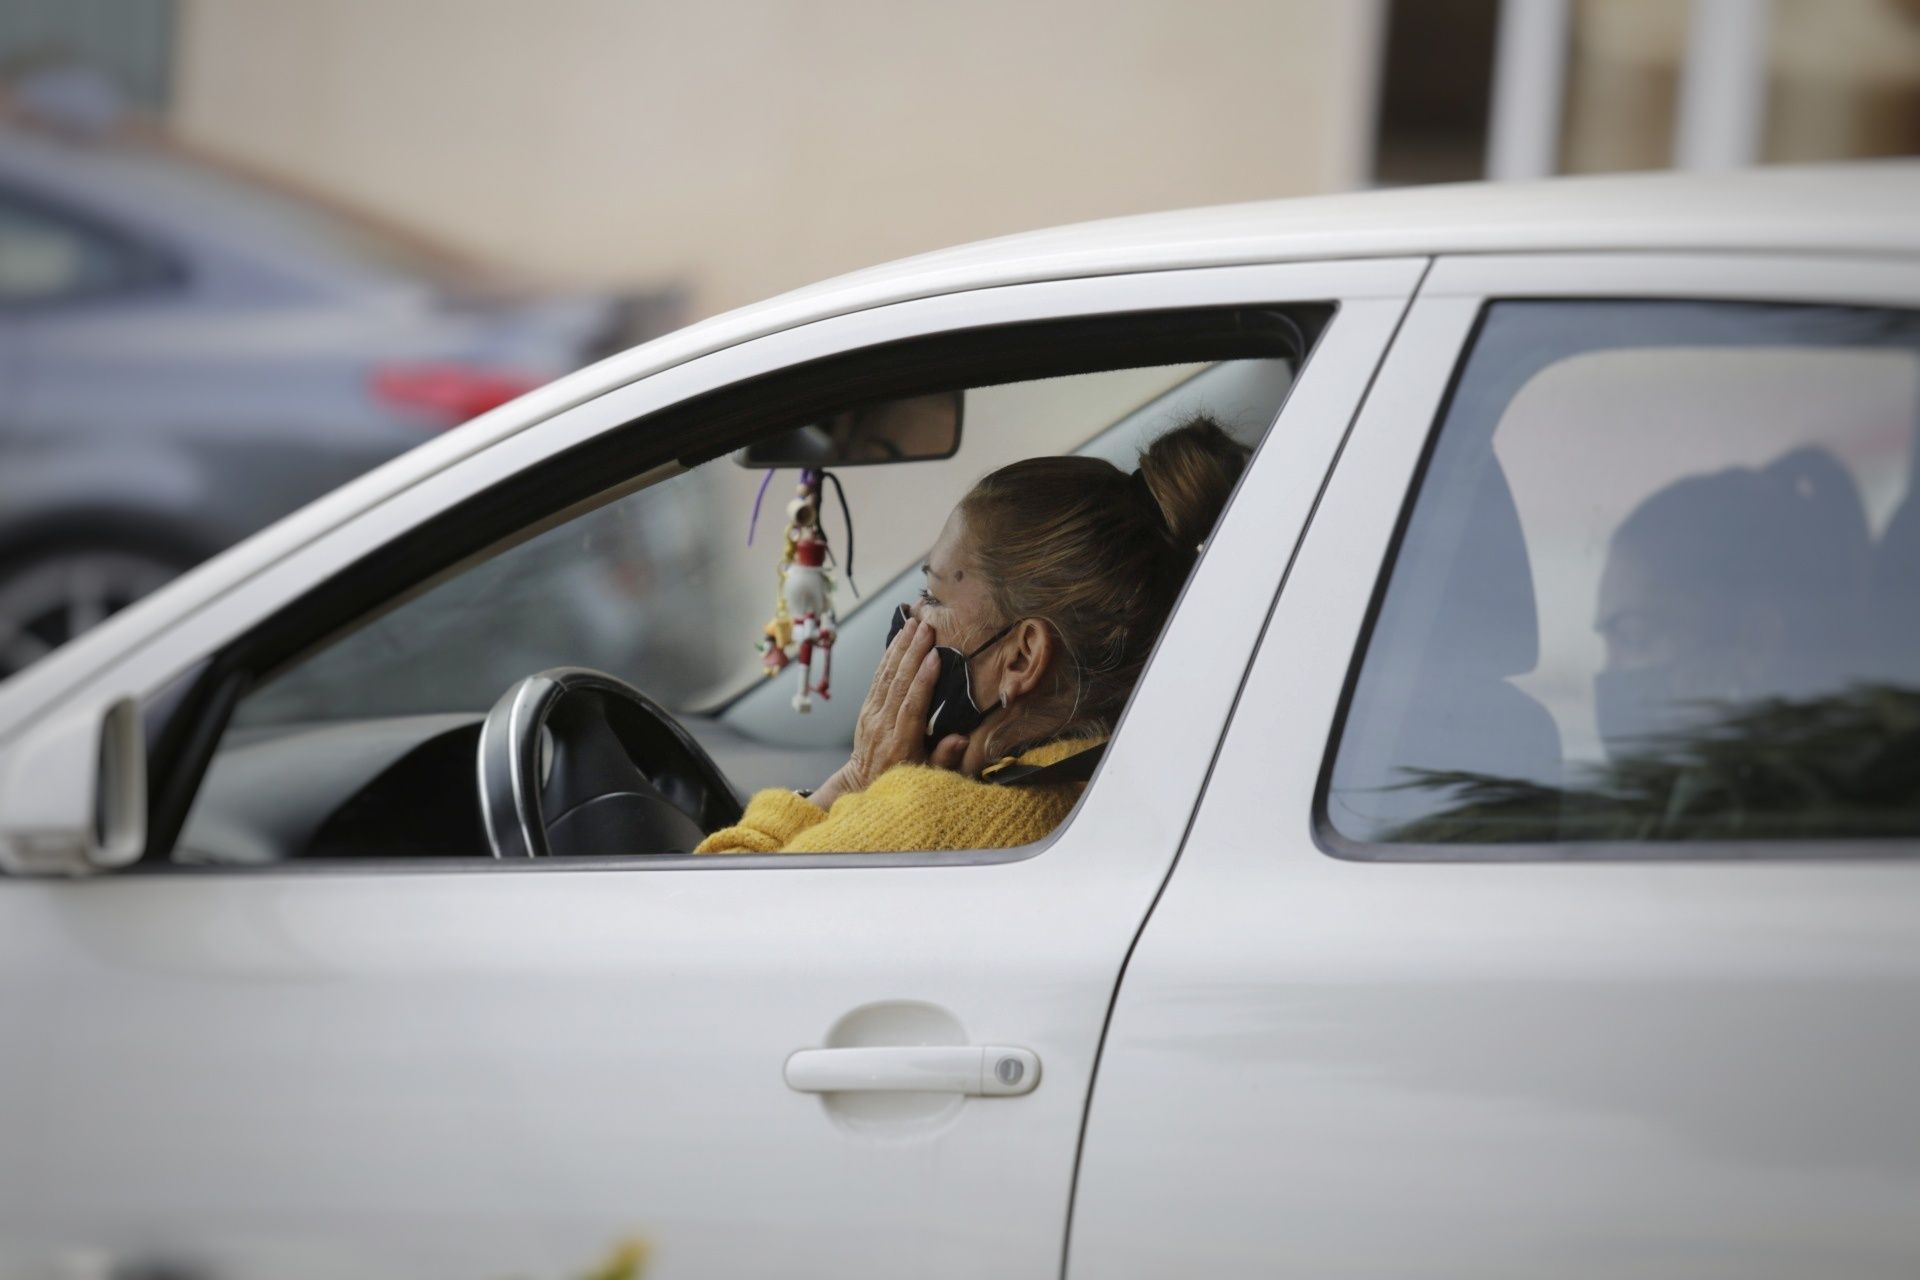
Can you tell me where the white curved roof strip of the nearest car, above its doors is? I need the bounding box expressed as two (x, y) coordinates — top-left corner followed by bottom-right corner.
(0, 161), (1920, 741)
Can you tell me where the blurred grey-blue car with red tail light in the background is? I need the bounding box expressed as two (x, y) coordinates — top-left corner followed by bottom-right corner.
(0, 87), (678, 679)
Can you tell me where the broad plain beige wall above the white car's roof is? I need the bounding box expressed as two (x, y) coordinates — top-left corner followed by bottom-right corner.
(173, 0), (1380, 315)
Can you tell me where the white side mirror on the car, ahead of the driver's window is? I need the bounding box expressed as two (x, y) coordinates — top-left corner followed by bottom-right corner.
(0, 699), (146, 875)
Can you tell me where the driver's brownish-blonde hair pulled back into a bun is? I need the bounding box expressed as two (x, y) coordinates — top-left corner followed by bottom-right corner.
(960, 416), (1248, 741)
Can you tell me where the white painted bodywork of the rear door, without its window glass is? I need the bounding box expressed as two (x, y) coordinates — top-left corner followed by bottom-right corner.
(1069, 255), (1920, 1280)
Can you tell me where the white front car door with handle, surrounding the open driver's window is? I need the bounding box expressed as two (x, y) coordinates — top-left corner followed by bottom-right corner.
(0, 261), (1423, 1276)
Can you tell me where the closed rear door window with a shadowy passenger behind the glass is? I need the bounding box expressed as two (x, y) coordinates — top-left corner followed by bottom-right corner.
(1321, 301), (1920, 856)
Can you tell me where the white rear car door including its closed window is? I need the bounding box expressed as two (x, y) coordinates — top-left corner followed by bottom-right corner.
(1068, 255), (1920, 1278)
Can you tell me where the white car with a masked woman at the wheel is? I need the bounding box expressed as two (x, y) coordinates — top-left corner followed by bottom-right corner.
(0, 163), (1920, 1280)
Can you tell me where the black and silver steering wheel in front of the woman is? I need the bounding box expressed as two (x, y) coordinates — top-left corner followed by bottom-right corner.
(480, 666), (741, 858)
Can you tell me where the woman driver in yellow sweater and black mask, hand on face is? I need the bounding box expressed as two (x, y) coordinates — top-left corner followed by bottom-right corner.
(697, 418), (1246, 854)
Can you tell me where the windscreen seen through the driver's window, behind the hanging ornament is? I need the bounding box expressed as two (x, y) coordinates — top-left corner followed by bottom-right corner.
(236, 361), (1271, 727)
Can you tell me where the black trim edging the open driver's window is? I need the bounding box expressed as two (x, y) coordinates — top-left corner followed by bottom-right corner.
(145, 303), (1340, 875)
